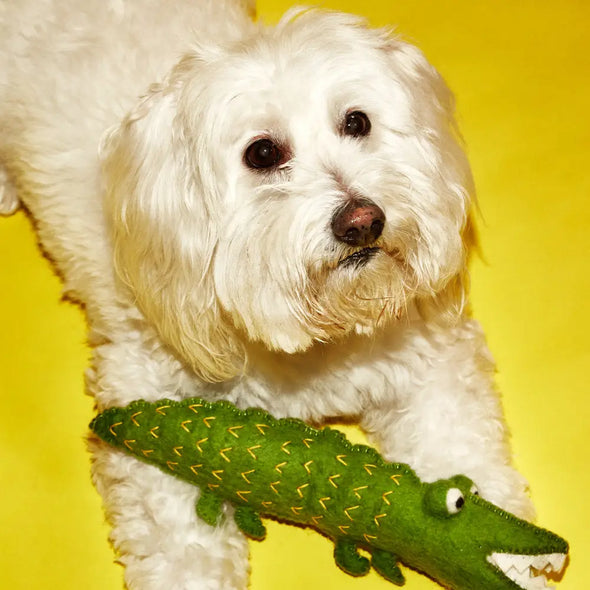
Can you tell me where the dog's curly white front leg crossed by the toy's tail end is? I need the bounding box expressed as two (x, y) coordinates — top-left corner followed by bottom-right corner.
(86, 332), (254, 590)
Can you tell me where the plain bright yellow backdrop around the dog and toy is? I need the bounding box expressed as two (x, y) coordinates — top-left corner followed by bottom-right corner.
(0, 0), (590, 590)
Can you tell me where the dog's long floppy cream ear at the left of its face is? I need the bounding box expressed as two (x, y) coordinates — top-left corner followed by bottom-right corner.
(102, 77), (243, 381)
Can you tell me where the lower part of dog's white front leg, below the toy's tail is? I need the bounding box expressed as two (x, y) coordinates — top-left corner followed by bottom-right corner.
(90, 440), (249, 590)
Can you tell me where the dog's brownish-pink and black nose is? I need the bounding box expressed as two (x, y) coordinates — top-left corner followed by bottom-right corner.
(332, 199), (385, 247)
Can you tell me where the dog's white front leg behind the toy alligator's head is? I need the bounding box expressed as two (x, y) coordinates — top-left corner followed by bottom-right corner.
(363, 320), (534, 518)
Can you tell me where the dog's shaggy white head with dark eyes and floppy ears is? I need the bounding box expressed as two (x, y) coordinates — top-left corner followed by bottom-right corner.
(106, 11), (470, 379)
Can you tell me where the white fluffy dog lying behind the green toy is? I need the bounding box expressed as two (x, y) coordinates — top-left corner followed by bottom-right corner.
(0, 0), (532, 590)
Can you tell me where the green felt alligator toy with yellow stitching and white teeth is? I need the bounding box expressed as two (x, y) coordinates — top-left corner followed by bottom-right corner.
(90, 398), (568, 590)
